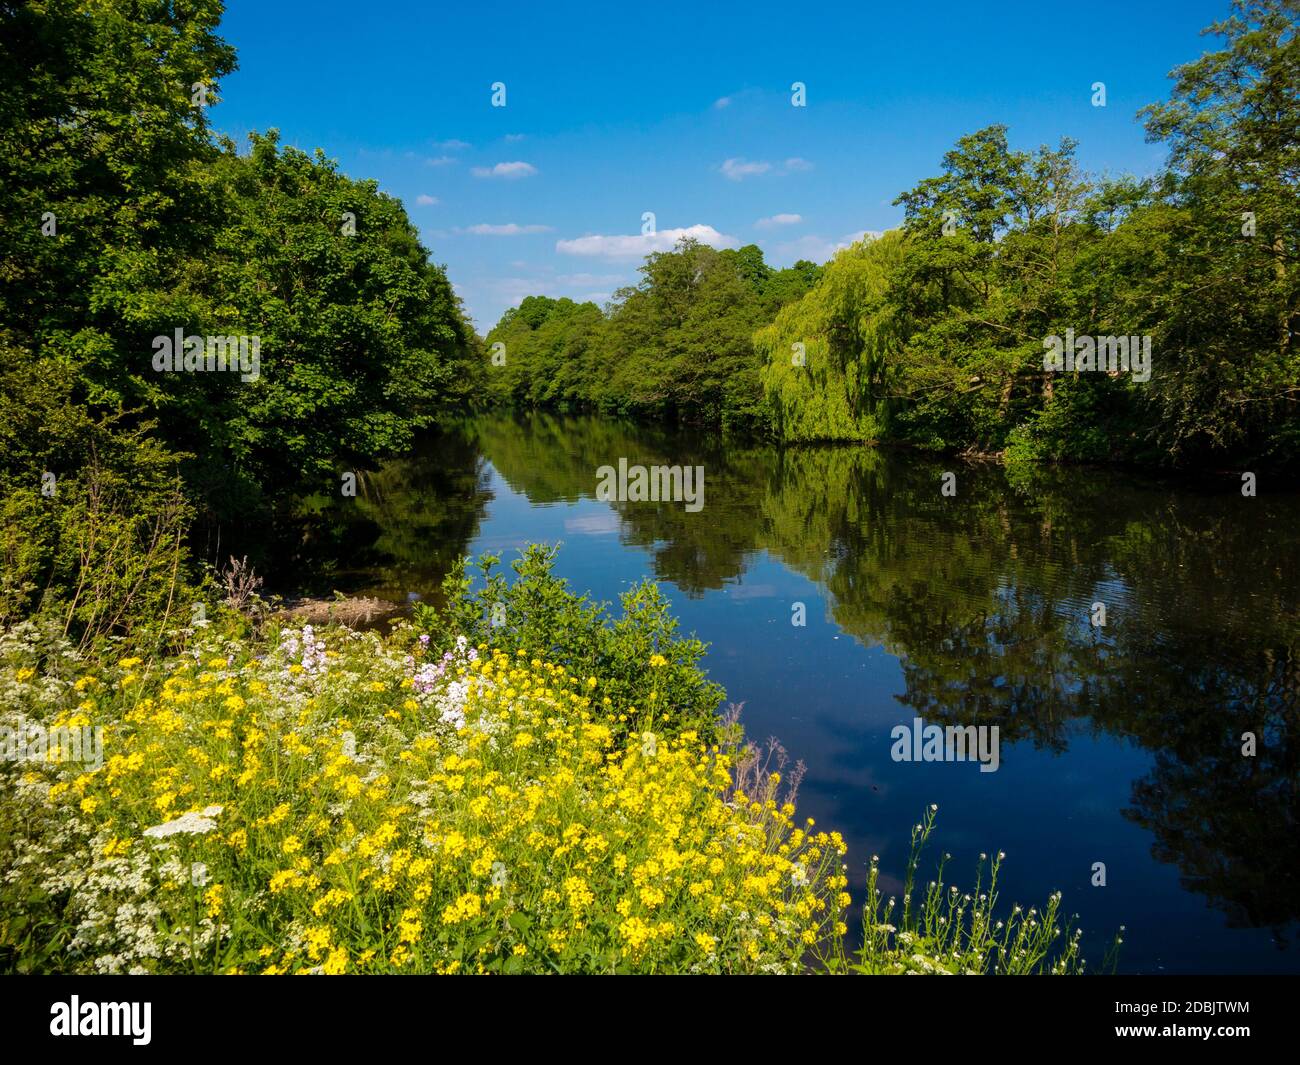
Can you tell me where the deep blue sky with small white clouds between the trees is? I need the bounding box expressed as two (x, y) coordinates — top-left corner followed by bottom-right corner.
(212, 0), (1227, 332)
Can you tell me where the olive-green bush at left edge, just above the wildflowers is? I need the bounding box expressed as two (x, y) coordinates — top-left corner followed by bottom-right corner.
(0, 348), (195, 645)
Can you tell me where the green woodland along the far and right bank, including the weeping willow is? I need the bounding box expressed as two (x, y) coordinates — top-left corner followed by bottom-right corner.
(488, 0), (1300, 468)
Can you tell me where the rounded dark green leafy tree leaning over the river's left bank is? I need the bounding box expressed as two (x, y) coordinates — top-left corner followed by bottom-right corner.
(167, 133), (473, 517)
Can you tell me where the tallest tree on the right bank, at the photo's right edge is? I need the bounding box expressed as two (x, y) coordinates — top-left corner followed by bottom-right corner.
(1132, 0), (1300, 463)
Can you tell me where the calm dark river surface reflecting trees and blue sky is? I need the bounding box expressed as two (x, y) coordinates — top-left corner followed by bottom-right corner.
(281, 416), (1300, 973)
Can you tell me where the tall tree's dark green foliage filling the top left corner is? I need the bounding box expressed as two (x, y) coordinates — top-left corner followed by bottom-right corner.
(0, 0), (235, 351)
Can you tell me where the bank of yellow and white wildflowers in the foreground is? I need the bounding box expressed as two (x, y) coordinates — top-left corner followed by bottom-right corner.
(0, 616), (850, 974)
